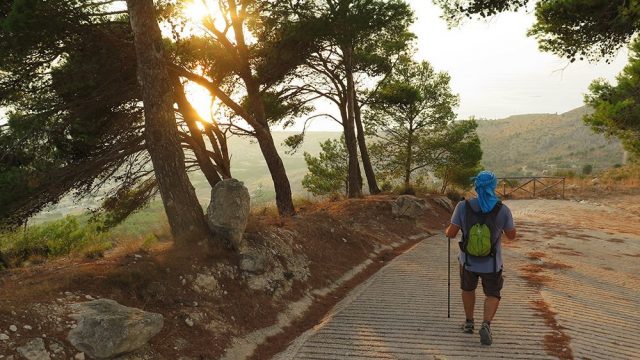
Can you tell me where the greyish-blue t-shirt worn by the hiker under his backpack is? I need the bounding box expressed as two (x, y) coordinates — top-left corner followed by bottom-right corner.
(451, 199), (515, 273)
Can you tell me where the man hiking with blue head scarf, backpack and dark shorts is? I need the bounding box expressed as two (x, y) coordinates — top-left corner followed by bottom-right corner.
(445, 171), (516, 345)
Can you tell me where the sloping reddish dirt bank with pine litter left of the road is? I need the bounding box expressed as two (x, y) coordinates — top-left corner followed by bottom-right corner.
(0, 195), (450, 360)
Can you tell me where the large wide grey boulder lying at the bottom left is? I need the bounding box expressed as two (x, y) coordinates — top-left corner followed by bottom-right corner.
(67, 299), (164, 359)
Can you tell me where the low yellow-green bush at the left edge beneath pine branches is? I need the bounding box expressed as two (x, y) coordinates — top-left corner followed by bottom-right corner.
(0, 216), (112, 266)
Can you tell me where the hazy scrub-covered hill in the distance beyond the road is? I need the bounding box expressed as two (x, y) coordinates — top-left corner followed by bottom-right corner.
(478, 107), (623, 176)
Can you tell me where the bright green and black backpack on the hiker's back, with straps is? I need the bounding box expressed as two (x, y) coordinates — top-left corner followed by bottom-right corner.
(460, 201), (502, 257)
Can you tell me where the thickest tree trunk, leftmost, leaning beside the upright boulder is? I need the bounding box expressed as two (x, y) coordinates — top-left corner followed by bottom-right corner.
(127, 0), (210, 243)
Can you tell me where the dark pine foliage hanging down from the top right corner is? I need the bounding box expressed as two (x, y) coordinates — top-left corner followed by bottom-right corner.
(435, 0), (640, 61)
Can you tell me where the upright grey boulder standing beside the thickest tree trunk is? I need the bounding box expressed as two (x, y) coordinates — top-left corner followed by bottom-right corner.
(207, 179), (251, 250)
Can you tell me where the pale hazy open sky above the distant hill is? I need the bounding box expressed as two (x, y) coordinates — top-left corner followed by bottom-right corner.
(296, 0), (627, 130)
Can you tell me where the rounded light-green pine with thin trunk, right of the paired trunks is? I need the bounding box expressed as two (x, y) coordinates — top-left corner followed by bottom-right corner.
(365, 58), (458, 184)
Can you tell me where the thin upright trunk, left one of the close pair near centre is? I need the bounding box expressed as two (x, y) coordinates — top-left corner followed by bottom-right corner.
(342, 46), (362, 198)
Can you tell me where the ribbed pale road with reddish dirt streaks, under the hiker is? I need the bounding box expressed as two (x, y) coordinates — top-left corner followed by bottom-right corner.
(278, 197), (640, 360)
